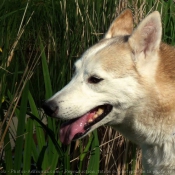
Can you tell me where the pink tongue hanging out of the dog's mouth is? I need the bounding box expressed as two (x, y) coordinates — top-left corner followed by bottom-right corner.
(60, 112), (95, 145)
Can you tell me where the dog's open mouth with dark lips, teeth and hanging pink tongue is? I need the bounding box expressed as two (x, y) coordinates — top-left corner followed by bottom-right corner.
(60, 104), (112, 145)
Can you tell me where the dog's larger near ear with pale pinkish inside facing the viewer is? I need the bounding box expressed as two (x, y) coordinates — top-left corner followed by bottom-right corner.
(128, 11), (162, 56)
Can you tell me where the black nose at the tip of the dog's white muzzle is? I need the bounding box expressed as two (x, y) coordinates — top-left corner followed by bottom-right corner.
(42, 100), (58, 116)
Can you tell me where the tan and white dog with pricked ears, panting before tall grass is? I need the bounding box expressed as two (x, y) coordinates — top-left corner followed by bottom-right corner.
(43, 9), (175, 175)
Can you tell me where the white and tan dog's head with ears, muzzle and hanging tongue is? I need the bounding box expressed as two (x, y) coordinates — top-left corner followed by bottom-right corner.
(43, 10), (161, 144)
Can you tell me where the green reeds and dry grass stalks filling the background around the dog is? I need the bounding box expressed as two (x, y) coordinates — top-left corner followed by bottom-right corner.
(0, 0), (175, 175)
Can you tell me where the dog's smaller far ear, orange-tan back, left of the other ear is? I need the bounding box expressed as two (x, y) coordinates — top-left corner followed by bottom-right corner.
(105, 9), (133, 38)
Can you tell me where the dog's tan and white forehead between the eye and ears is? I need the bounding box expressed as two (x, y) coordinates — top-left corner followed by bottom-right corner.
(76, 36), (133, 74)
